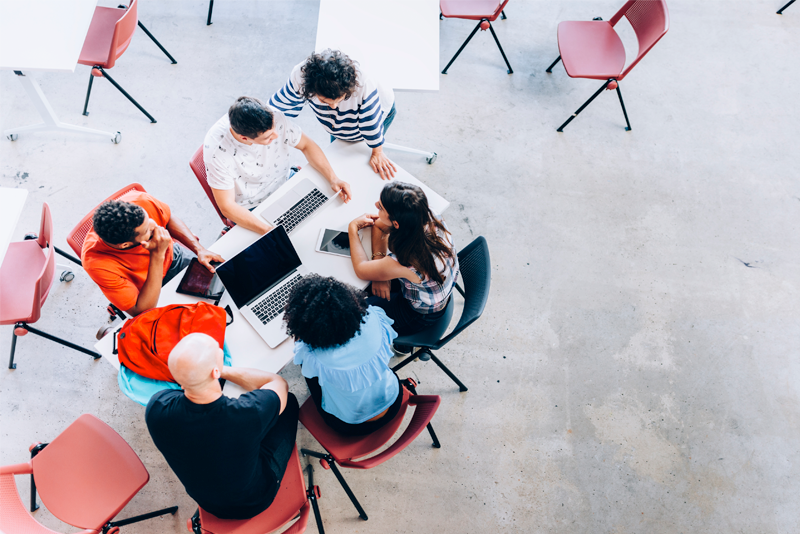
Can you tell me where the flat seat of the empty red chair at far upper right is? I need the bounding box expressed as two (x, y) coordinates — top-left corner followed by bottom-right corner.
(558, 20), (625, 80)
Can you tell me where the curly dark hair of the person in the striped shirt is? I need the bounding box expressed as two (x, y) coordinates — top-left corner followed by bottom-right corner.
(300, 49), (359, 100)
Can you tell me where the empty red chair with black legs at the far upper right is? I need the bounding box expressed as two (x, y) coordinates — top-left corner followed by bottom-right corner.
(547, 0), (669, 132)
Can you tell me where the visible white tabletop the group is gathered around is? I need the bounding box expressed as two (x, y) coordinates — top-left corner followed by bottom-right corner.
(95, 141), (450, 395)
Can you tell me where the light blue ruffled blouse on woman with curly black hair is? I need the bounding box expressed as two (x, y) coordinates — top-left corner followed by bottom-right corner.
(294, 306), (400, 425)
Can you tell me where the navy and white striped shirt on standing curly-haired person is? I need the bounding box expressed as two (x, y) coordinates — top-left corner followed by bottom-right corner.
(269, 61), (394, 148)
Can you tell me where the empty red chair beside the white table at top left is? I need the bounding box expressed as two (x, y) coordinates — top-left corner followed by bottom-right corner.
(78, 0), (156, 122)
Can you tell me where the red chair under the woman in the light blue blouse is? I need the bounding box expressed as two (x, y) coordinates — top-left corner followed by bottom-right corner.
(300, 378), (442, 521)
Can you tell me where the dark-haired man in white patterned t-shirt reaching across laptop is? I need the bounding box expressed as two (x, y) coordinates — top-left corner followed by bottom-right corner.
(203, 96), (350, 234)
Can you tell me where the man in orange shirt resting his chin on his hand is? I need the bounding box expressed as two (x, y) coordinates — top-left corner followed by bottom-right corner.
(81, 191), (225, 315)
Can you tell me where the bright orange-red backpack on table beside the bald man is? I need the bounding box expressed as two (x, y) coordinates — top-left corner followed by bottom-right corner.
(114, 302), (233, 382)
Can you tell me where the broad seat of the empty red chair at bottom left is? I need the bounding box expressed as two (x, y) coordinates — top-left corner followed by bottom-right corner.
(31, 414), (150, 530)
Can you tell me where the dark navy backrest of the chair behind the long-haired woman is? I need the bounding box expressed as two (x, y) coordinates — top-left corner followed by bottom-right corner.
(432, 236), (492, 349)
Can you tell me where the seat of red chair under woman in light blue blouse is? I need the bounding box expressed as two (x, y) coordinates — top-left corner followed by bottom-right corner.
(300, 394), (409, 463)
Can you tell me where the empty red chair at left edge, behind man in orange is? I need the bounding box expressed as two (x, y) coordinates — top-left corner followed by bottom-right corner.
(0, 202), (101, 369)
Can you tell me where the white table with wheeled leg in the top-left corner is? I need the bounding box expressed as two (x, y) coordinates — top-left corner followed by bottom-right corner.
(0, 0), (122, 143)
